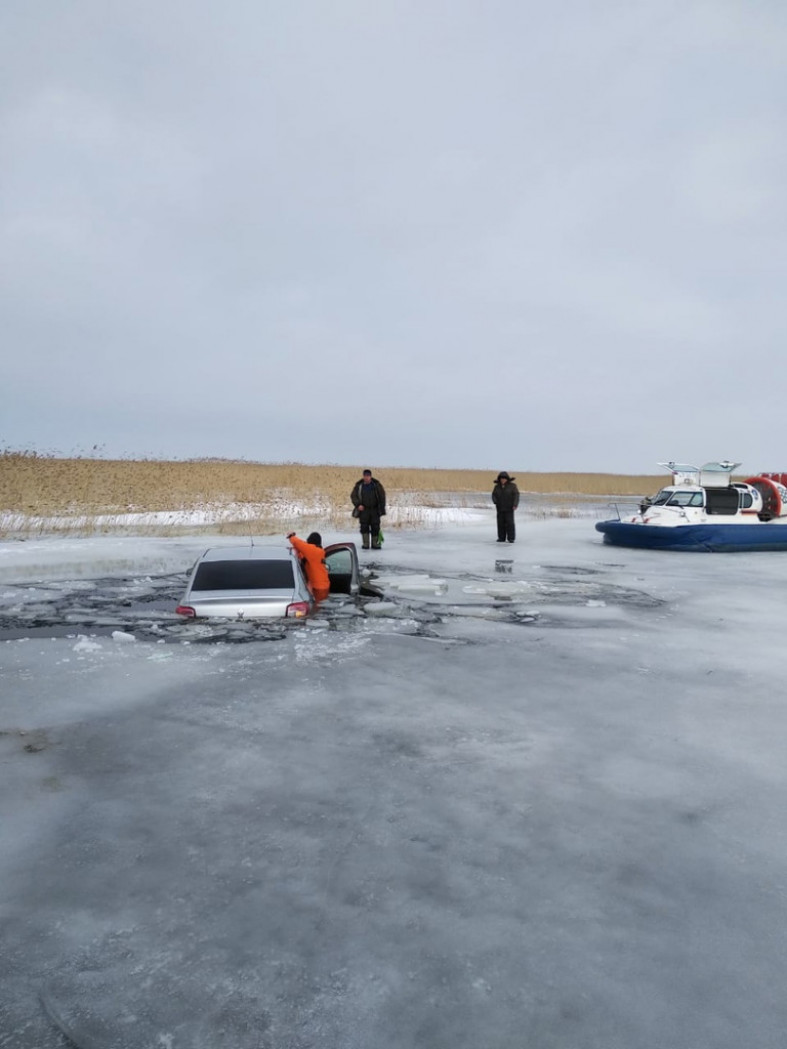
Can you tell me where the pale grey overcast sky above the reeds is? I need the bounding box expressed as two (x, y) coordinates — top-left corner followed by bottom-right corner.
(0, 0), (787, 473)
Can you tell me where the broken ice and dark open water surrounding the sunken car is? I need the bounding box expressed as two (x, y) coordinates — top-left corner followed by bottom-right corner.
(0, 557), (662, 644)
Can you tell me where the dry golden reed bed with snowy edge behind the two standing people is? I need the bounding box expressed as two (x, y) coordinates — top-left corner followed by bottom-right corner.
(0, 451), (663, 534)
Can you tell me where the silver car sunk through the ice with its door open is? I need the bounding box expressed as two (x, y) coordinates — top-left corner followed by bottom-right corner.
(175, 542), (359, 620)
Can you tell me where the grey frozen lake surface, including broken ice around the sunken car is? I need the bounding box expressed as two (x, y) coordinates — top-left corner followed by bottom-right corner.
(0, 511), (787, 1049)
